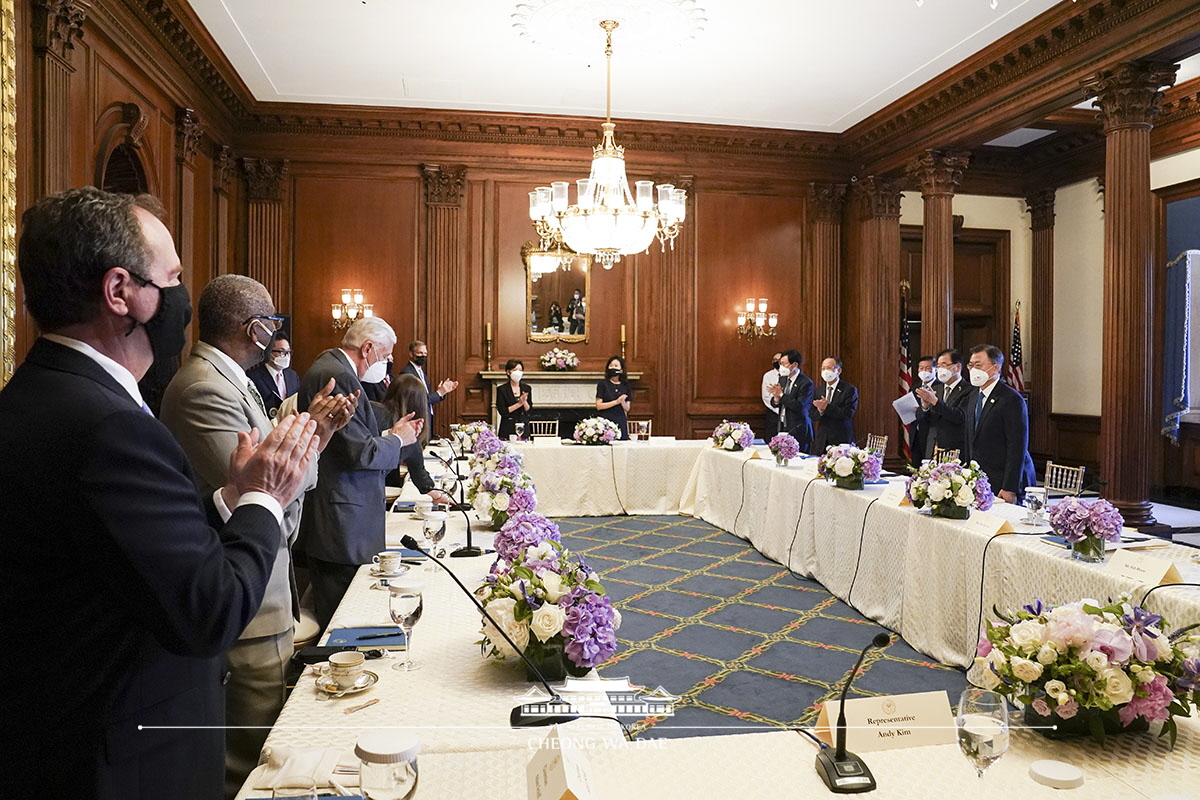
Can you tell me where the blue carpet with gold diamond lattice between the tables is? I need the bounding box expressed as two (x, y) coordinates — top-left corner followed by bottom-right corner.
(556, 517), (966, 738)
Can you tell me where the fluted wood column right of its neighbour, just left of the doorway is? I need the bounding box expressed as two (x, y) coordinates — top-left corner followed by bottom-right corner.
(854, 176), (904, 457)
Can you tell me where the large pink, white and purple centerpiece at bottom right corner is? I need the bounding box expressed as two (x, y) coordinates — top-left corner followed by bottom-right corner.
(968, 600), (1200, 746)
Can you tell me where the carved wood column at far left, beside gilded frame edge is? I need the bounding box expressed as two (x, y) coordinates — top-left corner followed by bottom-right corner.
(30, 0), (84, 199)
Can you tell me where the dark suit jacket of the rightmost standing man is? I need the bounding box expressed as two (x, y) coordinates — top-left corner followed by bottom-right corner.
(962, 381), (1036, 498)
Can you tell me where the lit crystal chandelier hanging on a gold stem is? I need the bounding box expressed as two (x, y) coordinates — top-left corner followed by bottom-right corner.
(529, 19), (688, 270)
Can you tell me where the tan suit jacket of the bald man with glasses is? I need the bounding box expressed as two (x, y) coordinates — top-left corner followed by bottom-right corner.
(161, 342), (318, 639)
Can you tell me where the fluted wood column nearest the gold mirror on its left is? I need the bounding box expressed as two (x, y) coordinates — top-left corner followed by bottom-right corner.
(416, 164), (467, 435)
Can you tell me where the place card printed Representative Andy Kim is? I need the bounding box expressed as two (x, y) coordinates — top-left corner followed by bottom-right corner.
(815, 691), (956, 753)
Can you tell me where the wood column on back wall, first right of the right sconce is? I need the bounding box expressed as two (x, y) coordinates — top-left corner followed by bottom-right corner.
(804, 184), (846, 361)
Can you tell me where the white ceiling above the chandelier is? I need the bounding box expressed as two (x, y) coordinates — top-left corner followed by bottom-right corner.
(191, 0), (1069, 132)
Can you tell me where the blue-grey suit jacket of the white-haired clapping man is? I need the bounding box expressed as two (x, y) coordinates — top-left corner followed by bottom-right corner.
(296, 348), (401, 565)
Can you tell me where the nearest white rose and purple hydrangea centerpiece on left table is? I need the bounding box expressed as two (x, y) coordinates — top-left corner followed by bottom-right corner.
(476, 539), (620, 680)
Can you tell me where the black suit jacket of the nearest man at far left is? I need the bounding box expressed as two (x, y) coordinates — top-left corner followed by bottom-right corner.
(0, 338), (280, 799)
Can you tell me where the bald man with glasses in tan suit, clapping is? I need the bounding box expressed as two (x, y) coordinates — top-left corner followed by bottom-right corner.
(161, 275), (354, 798)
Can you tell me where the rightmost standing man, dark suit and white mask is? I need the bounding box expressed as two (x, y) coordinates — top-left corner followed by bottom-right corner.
(964, 344), (1036, 503)
